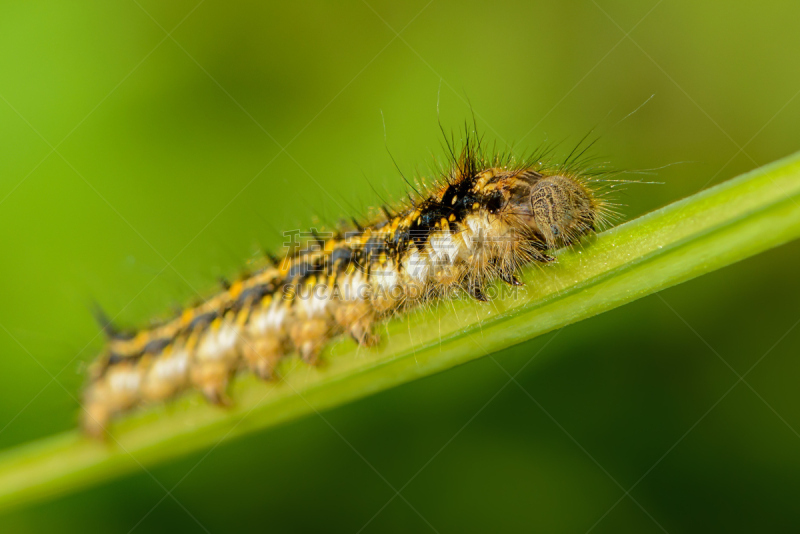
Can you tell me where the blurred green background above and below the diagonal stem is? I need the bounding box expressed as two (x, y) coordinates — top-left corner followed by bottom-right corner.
(0, 0), (800, 533)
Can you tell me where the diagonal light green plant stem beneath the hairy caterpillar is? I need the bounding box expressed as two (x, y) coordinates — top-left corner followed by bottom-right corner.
(0, 154), (800, 508)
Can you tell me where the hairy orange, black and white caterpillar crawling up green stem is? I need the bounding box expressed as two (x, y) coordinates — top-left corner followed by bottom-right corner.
(82, 131), (613, 437)
